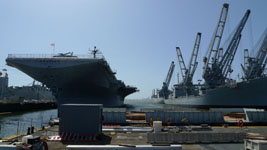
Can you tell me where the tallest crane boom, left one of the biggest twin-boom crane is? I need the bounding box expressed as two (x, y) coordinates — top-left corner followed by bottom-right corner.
(203, 3), (229, 77)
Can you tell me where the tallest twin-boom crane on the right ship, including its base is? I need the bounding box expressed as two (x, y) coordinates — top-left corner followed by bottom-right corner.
(202, 4), (250, 88)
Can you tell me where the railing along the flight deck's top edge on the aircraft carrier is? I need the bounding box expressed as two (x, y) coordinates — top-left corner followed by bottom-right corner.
(8, 53), (105, 59)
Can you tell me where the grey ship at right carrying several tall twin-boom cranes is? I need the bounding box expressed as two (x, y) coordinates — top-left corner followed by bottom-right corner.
(156, 4), (267, 109)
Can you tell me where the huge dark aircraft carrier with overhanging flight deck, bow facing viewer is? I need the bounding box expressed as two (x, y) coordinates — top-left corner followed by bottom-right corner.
(6, 48), (137, 107)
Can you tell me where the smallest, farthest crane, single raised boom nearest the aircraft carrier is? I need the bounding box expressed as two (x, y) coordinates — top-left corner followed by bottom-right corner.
(158, 61), (175, 99)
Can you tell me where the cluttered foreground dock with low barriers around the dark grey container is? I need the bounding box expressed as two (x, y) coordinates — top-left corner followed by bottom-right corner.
(0, 107), (267, 150)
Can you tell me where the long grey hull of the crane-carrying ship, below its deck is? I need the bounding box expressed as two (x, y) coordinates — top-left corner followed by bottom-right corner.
(164, 77), (267, 109)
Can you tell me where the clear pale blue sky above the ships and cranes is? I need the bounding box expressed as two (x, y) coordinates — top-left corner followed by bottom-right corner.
(0, 0), (267, 99)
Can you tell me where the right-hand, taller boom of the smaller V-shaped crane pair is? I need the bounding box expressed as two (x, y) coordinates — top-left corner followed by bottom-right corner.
(184, 32), (201, 85)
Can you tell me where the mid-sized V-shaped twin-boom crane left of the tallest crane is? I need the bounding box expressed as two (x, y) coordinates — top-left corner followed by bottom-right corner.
(176, 32), (201, 89)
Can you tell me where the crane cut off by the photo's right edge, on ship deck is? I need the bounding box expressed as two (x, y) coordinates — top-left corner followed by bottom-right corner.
(241, 28), (267, 80)
